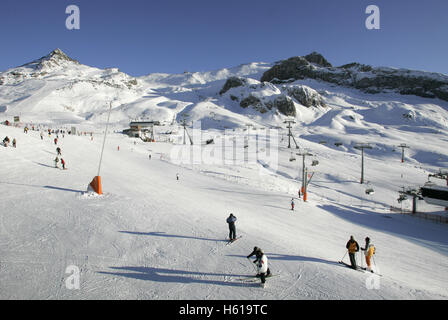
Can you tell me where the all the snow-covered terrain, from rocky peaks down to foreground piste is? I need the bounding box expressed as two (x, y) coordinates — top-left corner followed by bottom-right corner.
(0, 50), (448, 300)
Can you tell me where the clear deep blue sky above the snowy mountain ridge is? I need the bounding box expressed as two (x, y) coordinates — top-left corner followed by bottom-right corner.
(0, 0), (448, 76)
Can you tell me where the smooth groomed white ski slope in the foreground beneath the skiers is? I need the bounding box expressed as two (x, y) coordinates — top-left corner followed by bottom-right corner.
(0, 124), (448, 300)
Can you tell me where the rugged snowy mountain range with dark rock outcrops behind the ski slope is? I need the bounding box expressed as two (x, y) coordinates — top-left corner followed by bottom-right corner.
(0, 49), (448, 166)
